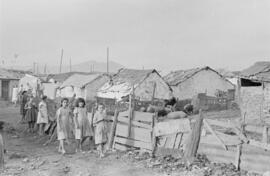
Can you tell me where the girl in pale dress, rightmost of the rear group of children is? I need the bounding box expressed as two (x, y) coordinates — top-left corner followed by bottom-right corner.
(37, 95), (49, 135)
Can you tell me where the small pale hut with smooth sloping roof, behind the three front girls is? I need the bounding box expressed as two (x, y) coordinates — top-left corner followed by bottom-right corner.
(60, 74), (109, 100)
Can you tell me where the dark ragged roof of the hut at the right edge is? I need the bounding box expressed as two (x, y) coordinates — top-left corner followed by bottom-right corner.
(240, 61), (270, 82)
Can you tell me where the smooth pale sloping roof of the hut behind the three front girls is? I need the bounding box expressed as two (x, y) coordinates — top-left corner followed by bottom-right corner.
(61, 74), (102, 88)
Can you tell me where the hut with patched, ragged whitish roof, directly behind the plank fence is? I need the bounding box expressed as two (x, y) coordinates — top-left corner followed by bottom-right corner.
(97, 69), (172, 101)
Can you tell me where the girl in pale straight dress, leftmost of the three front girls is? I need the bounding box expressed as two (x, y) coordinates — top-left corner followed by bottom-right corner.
(56, 98), (70, 154)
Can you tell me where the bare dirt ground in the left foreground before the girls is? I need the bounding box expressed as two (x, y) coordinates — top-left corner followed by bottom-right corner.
(0, 106), (164, 176)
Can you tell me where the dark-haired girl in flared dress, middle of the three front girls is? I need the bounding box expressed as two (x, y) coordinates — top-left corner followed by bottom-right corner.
(73, 98), (93, 152)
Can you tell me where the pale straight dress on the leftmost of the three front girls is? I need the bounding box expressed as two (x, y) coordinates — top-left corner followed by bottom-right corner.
(56, 107), (70, 140)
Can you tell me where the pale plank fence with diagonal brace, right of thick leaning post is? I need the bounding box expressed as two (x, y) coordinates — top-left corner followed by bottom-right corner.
(199, 119), (270, 173)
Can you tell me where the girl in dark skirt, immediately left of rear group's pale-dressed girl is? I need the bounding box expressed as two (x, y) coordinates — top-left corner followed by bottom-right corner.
(25, 96), (37, 133)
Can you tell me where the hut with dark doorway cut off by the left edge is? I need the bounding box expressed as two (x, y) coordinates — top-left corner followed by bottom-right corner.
(0, 68), (22, 101)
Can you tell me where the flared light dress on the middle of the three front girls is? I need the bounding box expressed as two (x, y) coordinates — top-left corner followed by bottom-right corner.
(73, 107), (93, 139)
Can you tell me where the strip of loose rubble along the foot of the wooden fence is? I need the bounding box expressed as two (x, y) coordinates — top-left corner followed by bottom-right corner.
(122, 151), (258, 176)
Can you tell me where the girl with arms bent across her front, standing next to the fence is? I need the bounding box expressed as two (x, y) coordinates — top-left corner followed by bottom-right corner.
(93, 104), (107, 158)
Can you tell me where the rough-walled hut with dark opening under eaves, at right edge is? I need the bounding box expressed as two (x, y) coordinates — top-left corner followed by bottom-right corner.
(238, 62), (270, 124)
